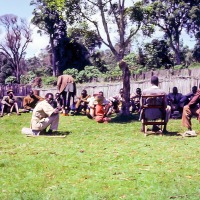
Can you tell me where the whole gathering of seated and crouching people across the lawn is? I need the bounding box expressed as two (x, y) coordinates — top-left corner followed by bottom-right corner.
(0, 76), (200, 134)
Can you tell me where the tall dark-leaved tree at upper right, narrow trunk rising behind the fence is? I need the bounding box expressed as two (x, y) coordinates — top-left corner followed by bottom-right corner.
(141, 0), (199, 64)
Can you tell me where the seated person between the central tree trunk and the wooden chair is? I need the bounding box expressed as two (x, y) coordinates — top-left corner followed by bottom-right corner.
(130, 88), (142, 113)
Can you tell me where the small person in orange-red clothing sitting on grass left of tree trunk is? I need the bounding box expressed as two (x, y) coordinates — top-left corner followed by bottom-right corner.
(95, 95), (111, 123)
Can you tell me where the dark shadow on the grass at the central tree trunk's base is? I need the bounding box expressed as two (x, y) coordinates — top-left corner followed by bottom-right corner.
(109, 114), (139, 124)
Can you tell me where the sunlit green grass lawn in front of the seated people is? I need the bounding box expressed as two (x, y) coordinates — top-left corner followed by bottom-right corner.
(0, 114), (200, 200)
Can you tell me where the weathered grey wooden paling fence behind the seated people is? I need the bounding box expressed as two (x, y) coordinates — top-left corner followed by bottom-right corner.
(0, 68), (200, 104)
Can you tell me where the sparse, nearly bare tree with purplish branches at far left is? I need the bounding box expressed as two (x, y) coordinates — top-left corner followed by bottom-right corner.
(0, 15), (32, 82)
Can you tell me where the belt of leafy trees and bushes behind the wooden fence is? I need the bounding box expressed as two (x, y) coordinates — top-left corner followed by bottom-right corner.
(0, 0), (200, 83)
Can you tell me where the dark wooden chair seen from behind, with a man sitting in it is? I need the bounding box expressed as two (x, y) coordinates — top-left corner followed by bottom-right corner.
(140, 95), (166, 136)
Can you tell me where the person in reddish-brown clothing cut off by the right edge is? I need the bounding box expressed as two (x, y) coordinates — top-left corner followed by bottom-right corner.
(182, 89), (200, 134)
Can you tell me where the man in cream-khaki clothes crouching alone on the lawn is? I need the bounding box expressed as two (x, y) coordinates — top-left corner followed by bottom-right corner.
(31, 93), (61, 135)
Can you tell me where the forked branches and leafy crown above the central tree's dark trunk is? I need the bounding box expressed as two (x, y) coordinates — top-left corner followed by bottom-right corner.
(48, 0), (142, 61)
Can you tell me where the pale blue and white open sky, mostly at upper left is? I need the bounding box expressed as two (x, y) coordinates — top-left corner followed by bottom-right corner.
(0, 0), (195, 58)
